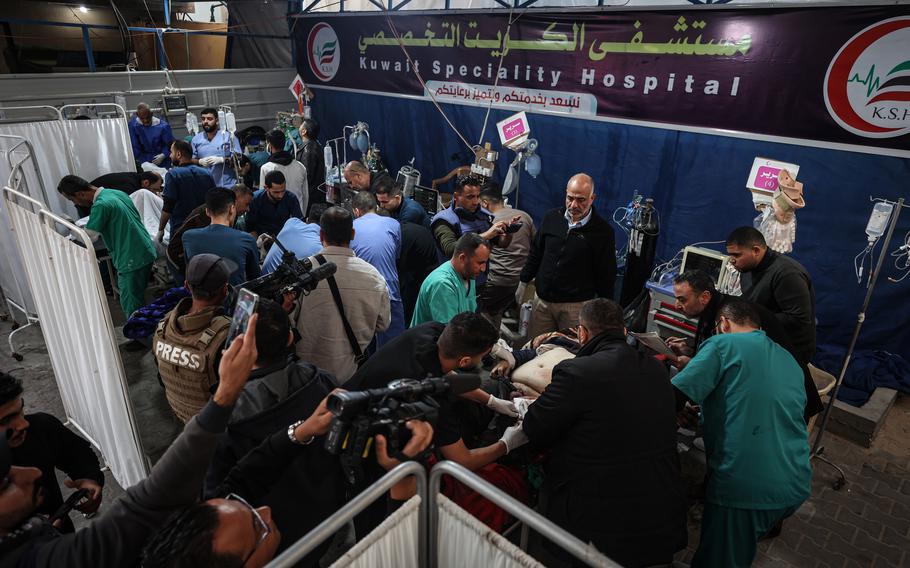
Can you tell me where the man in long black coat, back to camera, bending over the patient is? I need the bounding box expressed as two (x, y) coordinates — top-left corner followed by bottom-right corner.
(522, 298), (687, 566)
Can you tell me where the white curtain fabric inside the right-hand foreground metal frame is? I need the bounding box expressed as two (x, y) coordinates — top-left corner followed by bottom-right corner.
(438, 494), (544, 568)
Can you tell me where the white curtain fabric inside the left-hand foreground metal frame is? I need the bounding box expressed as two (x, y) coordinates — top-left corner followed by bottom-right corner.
(331, 495), (424, 568)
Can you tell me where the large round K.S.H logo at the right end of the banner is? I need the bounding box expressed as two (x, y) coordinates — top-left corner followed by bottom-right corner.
(824, 16), (910, 138)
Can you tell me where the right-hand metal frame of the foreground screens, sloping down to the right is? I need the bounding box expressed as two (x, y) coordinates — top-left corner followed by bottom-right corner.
(428, 461), (622, 568)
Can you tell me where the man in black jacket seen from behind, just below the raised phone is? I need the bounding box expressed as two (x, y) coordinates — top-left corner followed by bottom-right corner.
(205, 299), (345, 560)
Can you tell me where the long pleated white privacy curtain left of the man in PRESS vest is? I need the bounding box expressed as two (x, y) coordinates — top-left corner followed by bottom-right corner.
(4, 193), (147, 487)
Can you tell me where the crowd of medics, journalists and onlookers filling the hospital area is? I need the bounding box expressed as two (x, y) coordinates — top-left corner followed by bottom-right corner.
(0, 105), (821, 568)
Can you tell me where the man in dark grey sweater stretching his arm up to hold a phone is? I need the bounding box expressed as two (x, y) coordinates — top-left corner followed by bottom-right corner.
(0, 316), (257, 568)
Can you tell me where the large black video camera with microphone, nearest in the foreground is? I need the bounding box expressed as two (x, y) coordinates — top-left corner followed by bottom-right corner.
(325, 374), (480, 484)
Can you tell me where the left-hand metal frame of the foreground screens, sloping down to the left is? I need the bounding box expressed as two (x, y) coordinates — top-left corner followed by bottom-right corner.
(267, 462), (427, 568)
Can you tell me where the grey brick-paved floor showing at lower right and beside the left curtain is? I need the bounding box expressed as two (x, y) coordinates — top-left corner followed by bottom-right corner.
(0, 301), (910, 568)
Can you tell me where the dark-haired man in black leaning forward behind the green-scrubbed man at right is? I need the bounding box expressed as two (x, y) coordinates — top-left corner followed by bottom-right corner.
(667, 270), (824, 421)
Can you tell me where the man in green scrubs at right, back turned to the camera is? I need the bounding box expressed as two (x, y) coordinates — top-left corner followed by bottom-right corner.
(672, 299), (812, 568)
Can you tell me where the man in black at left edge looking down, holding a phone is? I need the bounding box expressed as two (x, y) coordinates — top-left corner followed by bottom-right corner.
(0, 372), (104, 533)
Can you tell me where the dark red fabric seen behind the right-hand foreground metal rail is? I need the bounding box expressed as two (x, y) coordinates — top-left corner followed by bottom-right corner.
(430, 452), (529, 532)
